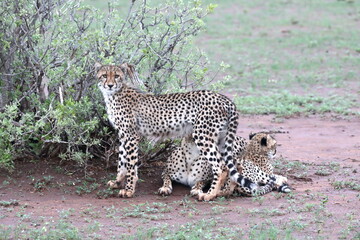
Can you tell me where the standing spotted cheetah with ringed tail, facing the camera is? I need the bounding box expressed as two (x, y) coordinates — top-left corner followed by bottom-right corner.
(95, 63), (258, 201)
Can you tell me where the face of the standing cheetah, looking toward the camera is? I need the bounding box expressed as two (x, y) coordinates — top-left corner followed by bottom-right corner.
(96, 65), (125, 95)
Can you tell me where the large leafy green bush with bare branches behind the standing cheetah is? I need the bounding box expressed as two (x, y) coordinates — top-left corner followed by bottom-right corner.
(0, 0), (219, 170)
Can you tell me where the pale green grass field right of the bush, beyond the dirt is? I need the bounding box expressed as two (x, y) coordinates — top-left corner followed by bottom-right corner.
(199, 0), (360, 115)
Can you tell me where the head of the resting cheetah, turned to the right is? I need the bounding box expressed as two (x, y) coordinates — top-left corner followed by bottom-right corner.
(249, 132), (276, 159)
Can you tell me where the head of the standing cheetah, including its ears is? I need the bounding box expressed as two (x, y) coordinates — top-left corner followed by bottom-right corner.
(95, 63), (137, 94)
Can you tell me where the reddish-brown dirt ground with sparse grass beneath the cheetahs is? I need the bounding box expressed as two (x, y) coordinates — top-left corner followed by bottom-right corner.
(0, 116), (360, 239)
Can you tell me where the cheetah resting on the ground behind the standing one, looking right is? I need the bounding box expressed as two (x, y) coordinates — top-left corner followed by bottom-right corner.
(158, 132), (290, 196)
